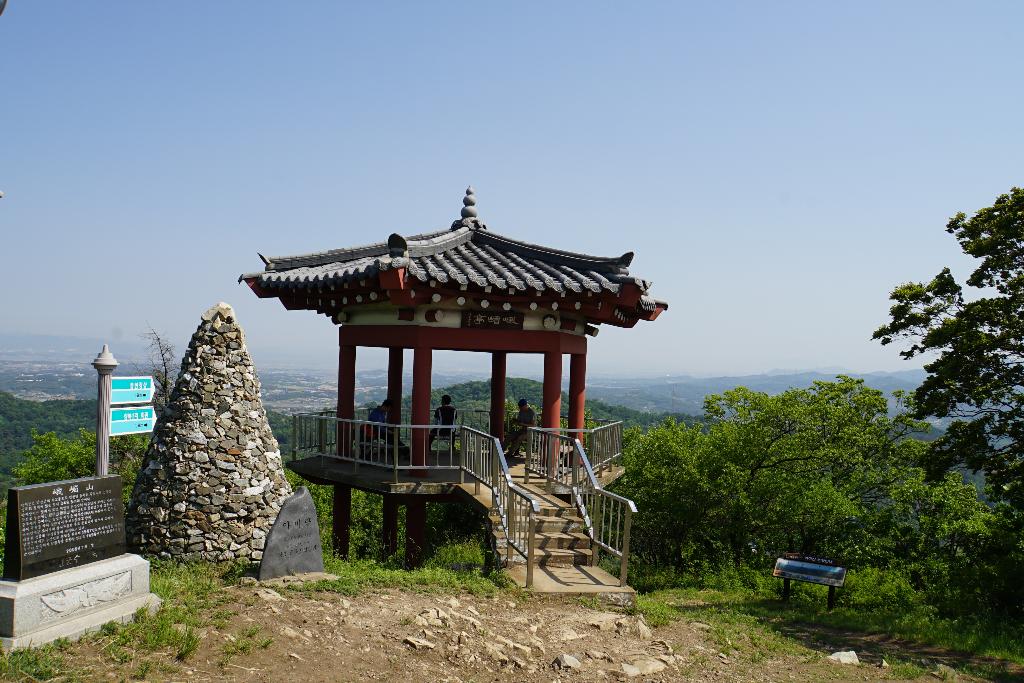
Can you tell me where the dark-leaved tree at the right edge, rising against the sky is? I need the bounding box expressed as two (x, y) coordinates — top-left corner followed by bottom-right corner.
(873, 187), (1024, 509)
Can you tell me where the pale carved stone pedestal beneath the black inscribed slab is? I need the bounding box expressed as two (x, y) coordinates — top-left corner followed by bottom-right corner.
(0, 554), (160, 651)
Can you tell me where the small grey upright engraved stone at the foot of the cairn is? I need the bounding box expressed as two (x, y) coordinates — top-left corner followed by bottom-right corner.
(259, 486), (324, 581)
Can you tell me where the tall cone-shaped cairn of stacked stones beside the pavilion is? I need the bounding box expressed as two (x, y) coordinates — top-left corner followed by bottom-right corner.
(125, 303), (292, 561)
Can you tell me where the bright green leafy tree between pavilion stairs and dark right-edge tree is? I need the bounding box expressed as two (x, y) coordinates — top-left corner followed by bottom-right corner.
(618, 377), (927, 573)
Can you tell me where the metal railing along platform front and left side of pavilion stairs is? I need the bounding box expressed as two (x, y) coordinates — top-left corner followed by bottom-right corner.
(292, 411), (541, 588)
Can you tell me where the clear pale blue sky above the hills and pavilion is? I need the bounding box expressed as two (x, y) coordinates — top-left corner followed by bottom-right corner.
(0, 0), (1024, 374)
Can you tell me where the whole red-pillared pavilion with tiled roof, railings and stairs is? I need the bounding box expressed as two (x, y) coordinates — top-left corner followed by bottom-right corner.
(240, 187), (668, 594)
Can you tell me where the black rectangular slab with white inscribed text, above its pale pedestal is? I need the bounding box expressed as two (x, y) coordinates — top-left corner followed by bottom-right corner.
(3, 475), (125, 581)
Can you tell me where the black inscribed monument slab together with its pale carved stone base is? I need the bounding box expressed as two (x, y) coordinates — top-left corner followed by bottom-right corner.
(0, 476), (160, 651)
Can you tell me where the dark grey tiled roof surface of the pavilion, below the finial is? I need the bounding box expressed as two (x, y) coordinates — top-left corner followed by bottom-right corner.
(240, 218), (659, 299)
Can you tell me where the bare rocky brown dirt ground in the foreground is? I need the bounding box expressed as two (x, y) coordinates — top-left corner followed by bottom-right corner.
(61, 586), (1007, 683)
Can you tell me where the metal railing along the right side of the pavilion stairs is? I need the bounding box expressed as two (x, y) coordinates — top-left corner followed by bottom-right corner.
(526, 428), (637, 586)
